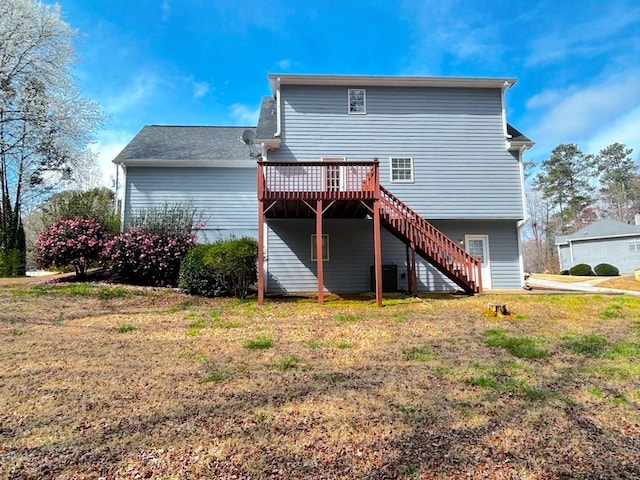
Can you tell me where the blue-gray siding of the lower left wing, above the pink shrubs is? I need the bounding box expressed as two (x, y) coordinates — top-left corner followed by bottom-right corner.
(124, 167), (258, 242)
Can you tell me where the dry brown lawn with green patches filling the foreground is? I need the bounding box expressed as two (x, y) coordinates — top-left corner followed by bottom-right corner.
(0, 284), (640, 479)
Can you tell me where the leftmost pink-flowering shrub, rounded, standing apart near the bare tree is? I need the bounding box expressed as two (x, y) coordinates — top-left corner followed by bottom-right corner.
(36, 217), (110, 277)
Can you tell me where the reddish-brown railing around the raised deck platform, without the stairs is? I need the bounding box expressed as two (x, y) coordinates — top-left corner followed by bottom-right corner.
(258, 160), (379, 200)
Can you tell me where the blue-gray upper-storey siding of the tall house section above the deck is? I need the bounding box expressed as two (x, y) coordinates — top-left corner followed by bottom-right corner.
(269, 85), (523, 220)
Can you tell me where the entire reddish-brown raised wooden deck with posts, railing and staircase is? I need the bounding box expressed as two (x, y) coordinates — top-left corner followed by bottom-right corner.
(257, 159), (482, 306)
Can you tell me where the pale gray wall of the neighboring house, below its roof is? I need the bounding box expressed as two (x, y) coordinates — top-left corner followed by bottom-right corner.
(559, 236), (640, 274)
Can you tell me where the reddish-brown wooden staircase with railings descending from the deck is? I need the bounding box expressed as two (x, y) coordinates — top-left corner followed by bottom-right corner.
(380, 185), (482, 294)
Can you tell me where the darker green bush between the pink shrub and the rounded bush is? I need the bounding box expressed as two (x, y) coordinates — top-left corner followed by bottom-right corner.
(178, 244), (228, 297)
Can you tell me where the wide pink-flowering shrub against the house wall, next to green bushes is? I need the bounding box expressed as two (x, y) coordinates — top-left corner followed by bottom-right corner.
(103, 227), (195, 286)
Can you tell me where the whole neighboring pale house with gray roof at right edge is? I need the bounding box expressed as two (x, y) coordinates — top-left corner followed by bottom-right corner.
(556, 216), (640, 274)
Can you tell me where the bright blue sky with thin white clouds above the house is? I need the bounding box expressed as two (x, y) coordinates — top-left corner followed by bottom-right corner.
(56, 0), (640, 186)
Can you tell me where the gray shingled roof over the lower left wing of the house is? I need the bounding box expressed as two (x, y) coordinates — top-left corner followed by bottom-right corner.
(113, 125), (255, 165)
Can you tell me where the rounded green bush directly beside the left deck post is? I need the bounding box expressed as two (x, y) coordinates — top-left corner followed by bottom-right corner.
(204, 237), (258, 298)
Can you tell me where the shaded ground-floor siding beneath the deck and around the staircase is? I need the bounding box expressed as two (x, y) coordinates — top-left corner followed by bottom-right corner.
(266, 219), (522, 294)
